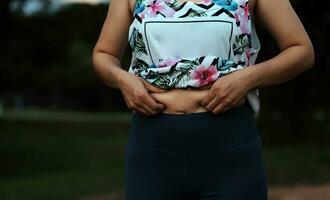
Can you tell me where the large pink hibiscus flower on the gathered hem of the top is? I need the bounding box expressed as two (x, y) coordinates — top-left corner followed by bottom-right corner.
(190, 65), (218, 87)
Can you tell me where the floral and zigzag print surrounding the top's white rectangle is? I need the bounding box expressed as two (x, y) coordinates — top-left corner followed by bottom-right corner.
(130, 0), (254, 86)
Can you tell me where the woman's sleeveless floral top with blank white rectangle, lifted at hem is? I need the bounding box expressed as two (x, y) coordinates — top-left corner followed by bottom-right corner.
(128, 0), (261, 117)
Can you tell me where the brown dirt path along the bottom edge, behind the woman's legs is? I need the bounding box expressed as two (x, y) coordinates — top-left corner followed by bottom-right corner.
(81, 184), (330, 200)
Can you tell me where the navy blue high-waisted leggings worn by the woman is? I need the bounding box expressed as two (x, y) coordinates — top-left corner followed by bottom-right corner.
(124, 104), (267, 200)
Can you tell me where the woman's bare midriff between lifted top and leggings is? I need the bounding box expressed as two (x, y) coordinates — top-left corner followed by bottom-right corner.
(150, 82), (245, 114)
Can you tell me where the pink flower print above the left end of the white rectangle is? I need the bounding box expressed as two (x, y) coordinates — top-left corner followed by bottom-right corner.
(146, 0), (175, 17)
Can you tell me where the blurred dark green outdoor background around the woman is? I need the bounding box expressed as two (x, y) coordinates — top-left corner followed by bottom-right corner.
(0, 0), (330, 200)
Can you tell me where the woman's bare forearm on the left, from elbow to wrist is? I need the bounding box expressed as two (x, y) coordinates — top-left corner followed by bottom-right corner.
(93, 52), (127, 89)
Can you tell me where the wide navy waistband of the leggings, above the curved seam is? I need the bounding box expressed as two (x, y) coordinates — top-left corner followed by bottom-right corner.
(128, 104), (259, 154)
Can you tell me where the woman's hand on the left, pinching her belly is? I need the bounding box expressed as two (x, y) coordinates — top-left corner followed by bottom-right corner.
(118, 72), (166, 116)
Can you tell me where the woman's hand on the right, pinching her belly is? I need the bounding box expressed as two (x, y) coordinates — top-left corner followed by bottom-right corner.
(201, 69), (251, 114)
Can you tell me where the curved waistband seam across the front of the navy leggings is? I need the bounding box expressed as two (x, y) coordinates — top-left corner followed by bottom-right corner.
(131, 132), (259, 155)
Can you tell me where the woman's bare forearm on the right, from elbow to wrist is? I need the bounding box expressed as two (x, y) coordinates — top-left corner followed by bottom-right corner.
(244, 45), (314, 89)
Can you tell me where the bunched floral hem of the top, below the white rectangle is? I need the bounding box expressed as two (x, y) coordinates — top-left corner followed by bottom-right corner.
(131, 56), (243, 89)
